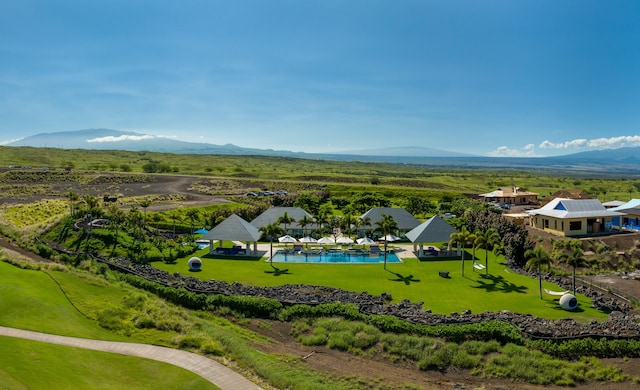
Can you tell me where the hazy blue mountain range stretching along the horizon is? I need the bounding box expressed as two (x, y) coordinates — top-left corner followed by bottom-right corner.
(7, 129), (640, 178)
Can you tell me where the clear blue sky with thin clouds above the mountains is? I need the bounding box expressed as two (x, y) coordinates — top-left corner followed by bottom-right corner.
(0, 0), (640, 156)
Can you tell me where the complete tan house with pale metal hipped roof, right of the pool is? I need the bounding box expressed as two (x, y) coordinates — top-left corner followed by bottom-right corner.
(527, 198), (624, 237)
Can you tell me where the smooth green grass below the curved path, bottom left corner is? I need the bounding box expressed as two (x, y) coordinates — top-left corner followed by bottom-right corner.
(0, 337), (217, 389)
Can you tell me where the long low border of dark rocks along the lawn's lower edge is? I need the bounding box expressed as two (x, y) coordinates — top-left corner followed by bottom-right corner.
(43, 241), (640, 339)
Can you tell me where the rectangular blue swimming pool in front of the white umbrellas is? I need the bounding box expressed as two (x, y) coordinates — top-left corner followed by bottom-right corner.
(267, 251), (402, 264)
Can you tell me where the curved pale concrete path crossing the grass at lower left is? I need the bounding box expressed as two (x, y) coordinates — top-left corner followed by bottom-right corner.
(0, 326), (261, 390)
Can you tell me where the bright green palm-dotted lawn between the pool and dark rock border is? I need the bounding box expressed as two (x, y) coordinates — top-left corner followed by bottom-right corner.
(153, 245), (607, 321)
